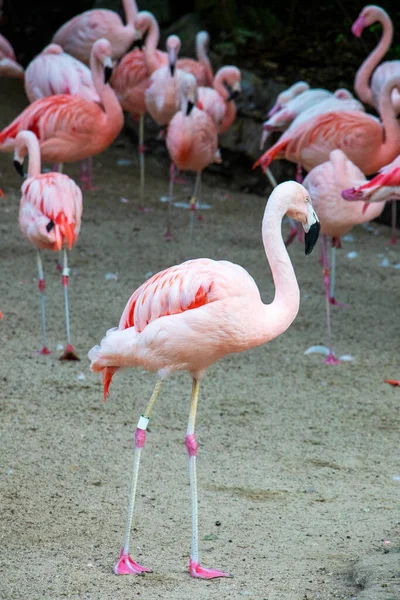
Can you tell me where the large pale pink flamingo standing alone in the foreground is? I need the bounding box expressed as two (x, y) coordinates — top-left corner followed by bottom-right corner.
(89, 180), (319, 579)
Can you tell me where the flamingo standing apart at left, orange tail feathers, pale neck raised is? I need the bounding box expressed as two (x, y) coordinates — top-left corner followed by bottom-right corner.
(14, 131), (82, 360)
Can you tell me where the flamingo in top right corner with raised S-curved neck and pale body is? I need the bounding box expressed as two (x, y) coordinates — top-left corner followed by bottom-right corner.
(351, 5), (400, 115)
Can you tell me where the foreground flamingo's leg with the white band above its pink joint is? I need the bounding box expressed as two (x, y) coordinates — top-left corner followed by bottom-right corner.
(114, 379), (163, 575)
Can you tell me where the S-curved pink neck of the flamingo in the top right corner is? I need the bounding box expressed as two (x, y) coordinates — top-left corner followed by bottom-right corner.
(354, 9), (393, 106)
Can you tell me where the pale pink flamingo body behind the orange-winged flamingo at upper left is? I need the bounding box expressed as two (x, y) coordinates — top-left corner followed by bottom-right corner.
(25, 44), (100, 103)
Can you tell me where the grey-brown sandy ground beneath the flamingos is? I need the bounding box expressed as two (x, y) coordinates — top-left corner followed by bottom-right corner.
(0, 82), (400, 600)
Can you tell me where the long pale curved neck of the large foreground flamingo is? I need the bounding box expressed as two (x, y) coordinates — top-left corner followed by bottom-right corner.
(262, 190), (300, 339)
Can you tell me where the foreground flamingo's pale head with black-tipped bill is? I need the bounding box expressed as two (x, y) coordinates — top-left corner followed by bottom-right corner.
(284, 181), (321, 256)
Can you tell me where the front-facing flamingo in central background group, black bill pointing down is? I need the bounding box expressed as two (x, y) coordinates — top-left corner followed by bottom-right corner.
(165, 73), (221, 238)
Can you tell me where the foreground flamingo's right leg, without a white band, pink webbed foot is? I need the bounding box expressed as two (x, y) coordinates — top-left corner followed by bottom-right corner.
(185, 379), (230, 579)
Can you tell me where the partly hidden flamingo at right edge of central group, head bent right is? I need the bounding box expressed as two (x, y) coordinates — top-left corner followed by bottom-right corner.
(197, 66), (241, 133)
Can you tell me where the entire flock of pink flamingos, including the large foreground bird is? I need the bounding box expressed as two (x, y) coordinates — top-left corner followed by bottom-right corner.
(0, 0), (400, 579)
